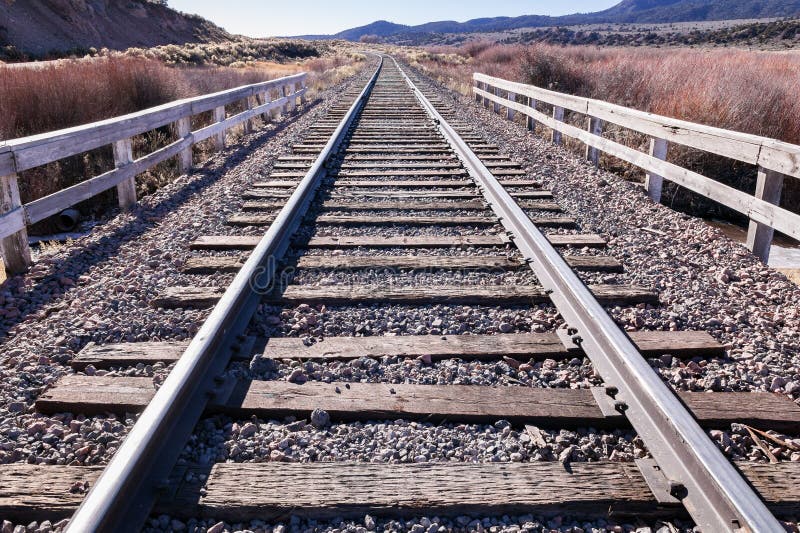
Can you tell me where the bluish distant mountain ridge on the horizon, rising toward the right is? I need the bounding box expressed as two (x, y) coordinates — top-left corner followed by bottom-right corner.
(306, 0), (800, 41)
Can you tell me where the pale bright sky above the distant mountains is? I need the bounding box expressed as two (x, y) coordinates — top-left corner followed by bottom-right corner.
(168, 0), (619, 37)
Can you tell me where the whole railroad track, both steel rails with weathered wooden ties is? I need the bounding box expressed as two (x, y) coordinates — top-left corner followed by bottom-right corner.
(0, 57), (800, 531)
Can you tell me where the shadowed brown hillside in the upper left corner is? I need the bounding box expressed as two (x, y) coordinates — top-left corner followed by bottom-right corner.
(0, 0), (230, 57)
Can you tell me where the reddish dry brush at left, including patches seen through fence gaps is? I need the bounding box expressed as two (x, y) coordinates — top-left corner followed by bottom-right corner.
(0, 54), (365, 233)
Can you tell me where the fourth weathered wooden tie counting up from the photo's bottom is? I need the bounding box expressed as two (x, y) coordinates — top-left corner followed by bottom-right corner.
(151, 285), (659, 309)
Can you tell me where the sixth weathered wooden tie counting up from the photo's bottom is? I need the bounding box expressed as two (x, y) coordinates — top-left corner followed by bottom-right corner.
(191, 233), (606, 250)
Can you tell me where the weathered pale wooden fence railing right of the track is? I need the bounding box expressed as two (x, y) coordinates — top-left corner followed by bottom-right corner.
(473, 73), (800, 262)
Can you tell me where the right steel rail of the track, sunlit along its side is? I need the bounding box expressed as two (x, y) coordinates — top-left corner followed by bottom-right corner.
(392, 58), (784, 533)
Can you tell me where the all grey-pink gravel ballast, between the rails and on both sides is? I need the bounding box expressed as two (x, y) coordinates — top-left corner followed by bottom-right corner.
(0, 56), (800, 533)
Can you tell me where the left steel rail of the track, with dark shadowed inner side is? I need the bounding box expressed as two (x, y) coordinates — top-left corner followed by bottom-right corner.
(67, 58), (383, 533)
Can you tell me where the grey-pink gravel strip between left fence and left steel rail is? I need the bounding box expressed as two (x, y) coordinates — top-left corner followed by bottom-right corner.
(0, 64), (376, 465)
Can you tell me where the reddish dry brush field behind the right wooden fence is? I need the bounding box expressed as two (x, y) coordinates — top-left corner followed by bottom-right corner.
(409, 42), (800, 144)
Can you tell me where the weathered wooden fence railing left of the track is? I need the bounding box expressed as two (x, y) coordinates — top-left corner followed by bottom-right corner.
(0, 73), (306, 272)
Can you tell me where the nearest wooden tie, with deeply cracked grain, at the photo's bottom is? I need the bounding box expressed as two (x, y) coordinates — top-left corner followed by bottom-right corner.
(6, 462), (800, 523)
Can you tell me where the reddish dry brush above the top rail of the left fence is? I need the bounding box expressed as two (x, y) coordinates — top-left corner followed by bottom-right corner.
(0, 57), (301, 139)
